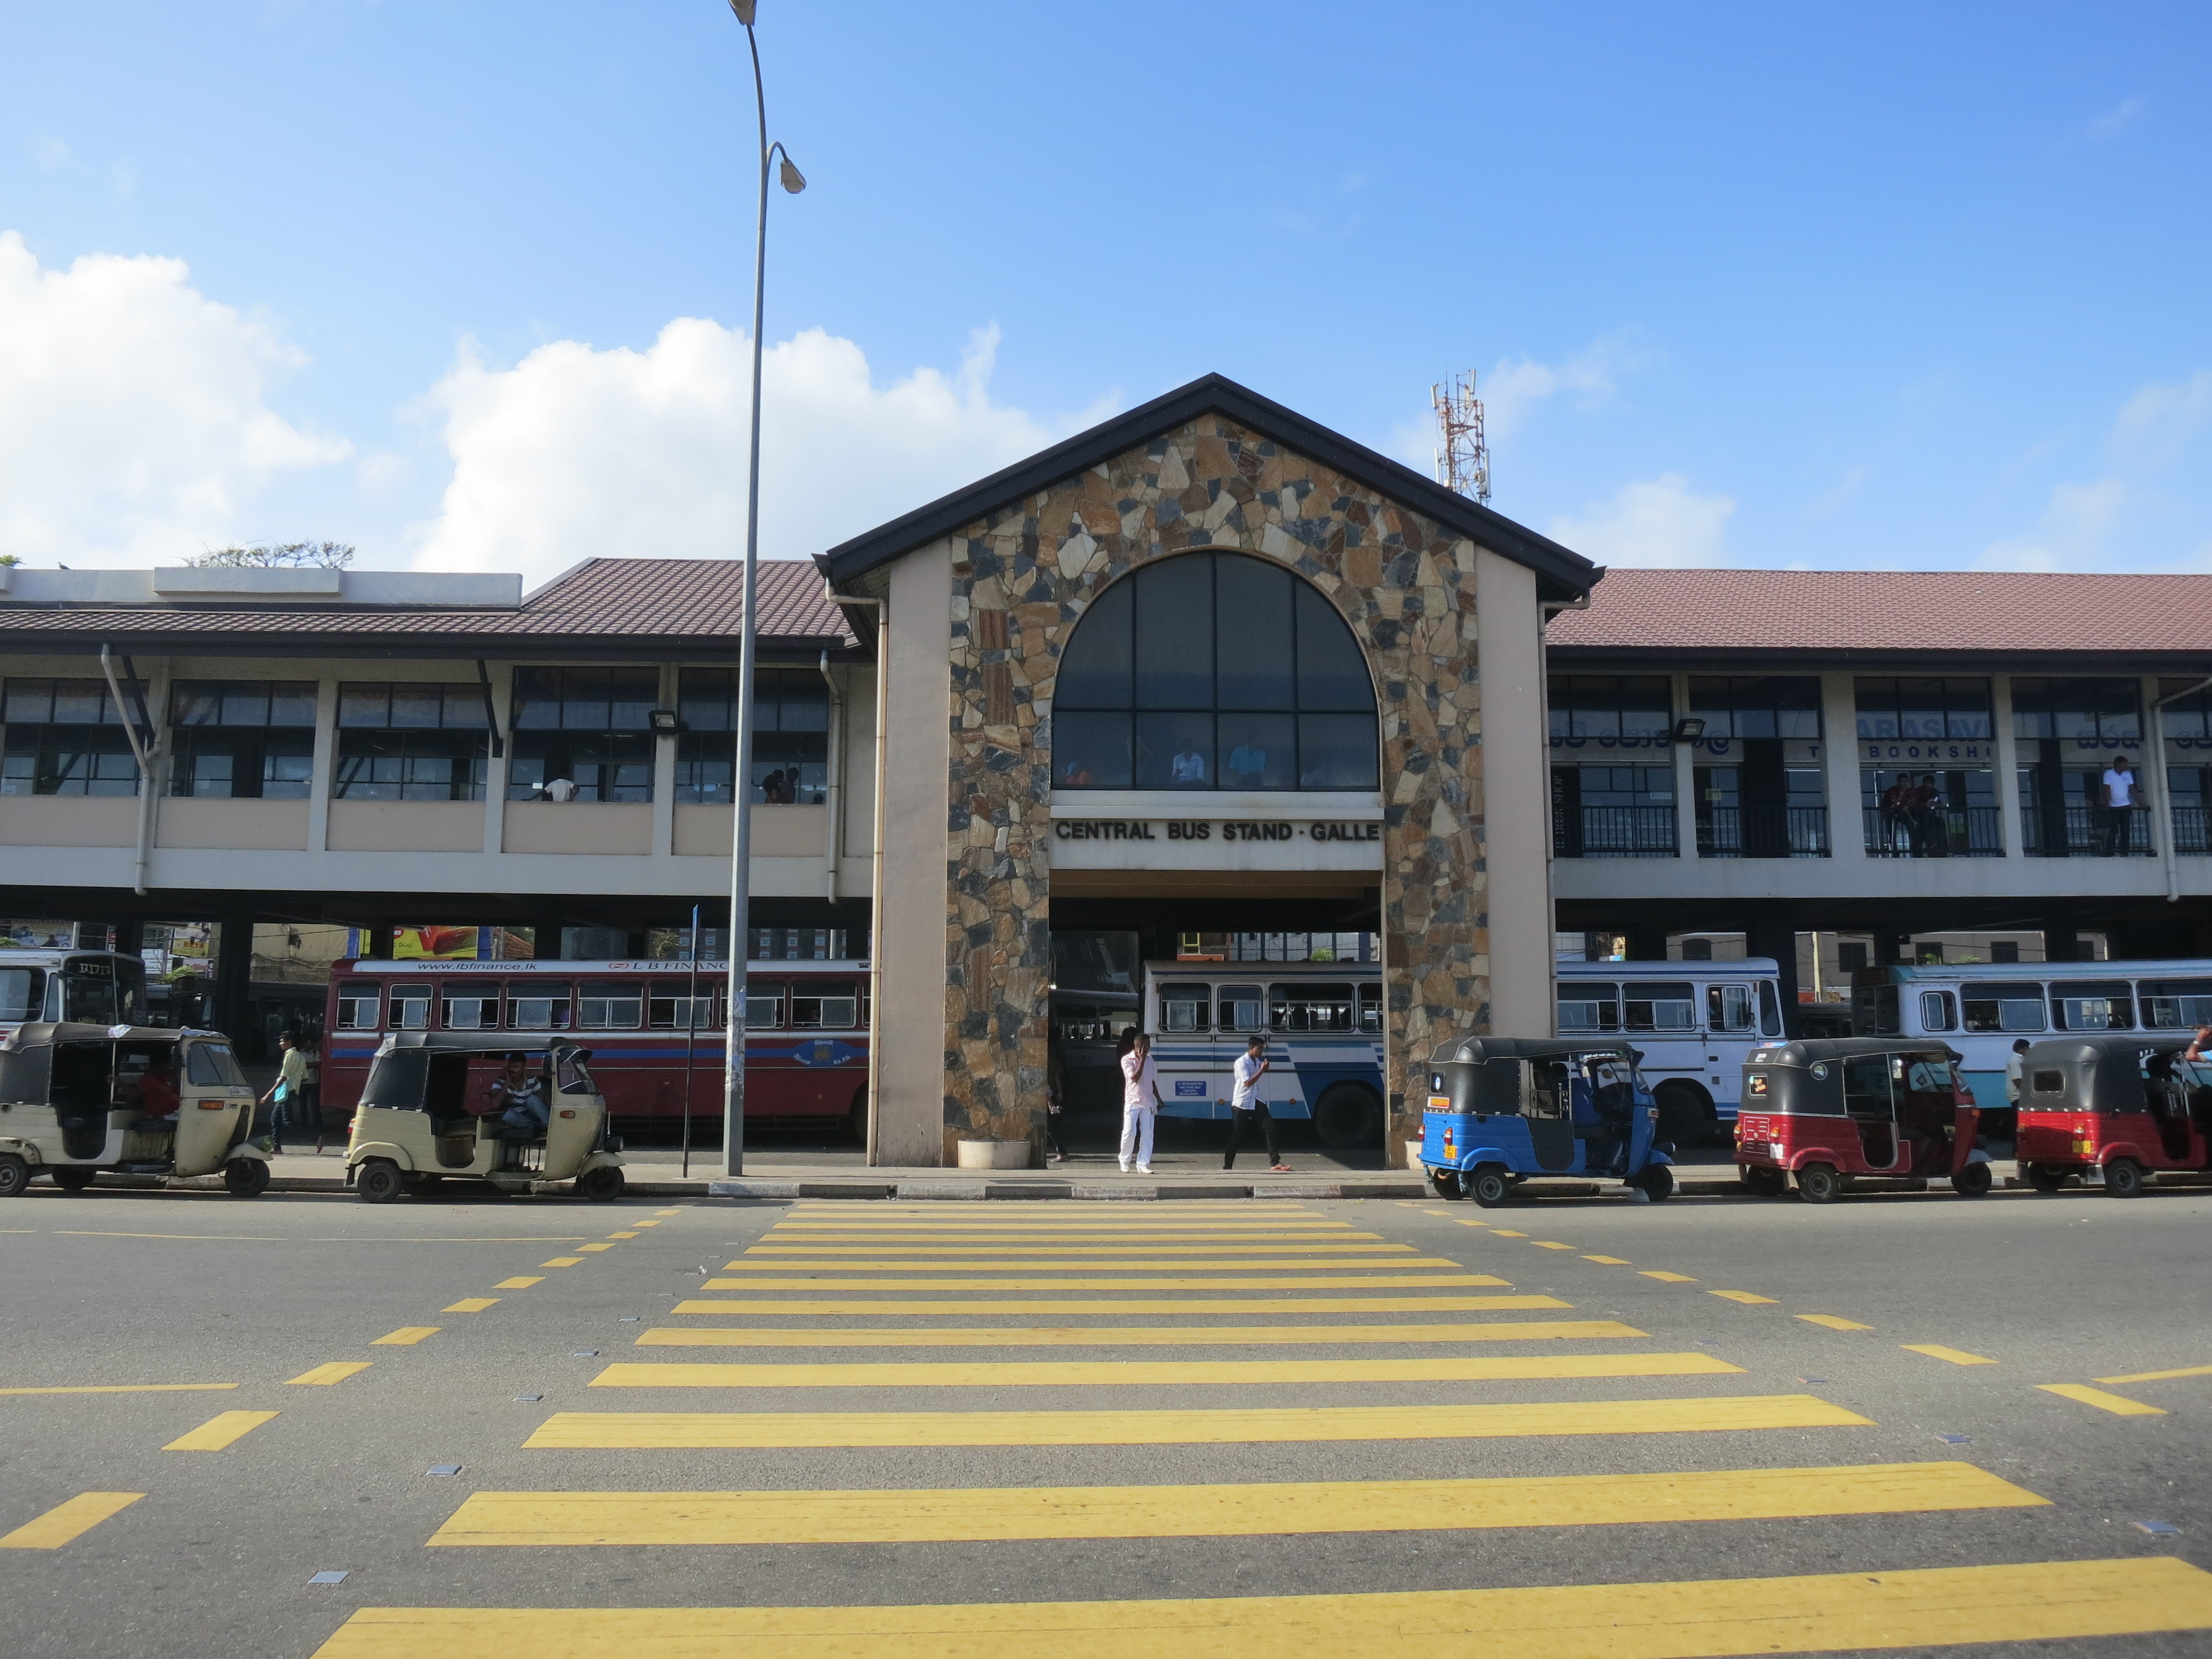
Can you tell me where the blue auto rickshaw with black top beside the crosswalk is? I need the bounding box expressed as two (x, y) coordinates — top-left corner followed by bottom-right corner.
(1420, 1037), (1674, 1208)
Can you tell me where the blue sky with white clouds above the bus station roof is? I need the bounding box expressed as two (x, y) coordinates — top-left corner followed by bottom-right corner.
(0, 0), (2212, 593)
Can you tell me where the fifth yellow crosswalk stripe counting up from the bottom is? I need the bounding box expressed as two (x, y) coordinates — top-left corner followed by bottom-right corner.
(637, 1307), (1648, 1347)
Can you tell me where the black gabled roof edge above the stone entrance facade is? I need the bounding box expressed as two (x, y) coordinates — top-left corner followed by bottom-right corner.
(814, 374), (1604, 599)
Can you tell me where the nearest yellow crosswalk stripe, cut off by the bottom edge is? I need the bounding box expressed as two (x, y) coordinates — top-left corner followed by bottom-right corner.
(299, 1557), (2212, 1659)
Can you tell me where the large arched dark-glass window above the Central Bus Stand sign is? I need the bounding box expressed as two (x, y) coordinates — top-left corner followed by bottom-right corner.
(1053, 553), (1376, 790)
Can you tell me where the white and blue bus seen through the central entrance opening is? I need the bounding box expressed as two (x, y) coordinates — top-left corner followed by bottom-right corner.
(1144, 962), (1383, 1148)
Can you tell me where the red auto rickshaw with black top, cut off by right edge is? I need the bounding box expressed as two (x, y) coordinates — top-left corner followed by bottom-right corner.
(2013, 1033), (2212, 1199)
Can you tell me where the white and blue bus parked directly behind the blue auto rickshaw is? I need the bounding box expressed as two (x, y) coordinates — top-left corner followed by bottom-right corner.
(1557, 956), (1783, 1144)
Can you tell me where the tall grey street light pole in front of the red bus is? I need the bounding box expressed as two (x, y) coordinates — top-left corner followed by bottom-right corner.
(721, 0), (807, 1175)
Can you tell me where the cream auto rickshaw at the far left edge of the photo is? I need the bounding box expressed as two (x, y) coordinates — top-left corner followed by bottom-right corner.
(0, 1020), (270, 1199)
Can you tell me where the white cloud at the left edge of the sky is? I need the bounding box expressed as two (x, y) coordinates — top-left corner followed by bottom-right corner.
(0, 232), (352, 566)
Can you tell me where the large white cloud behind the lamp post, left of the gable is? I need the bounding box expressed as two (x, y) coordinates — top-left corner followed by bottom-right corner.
(414, 316), (1088, 584)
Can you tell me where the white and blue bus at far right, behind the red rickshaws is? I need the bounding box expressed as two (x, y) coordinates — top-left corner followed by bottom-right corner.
(1851, 958), (2212, 1113)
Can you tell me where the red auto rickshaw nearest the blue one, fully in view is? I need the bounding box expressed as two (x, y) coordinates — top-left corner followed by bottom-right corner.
(1736, 1037), (1993, 1203)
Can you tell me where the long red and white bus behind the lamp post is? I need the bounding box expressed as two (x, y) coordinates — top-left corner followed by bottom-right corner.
(323, 960), (867, 1137)
